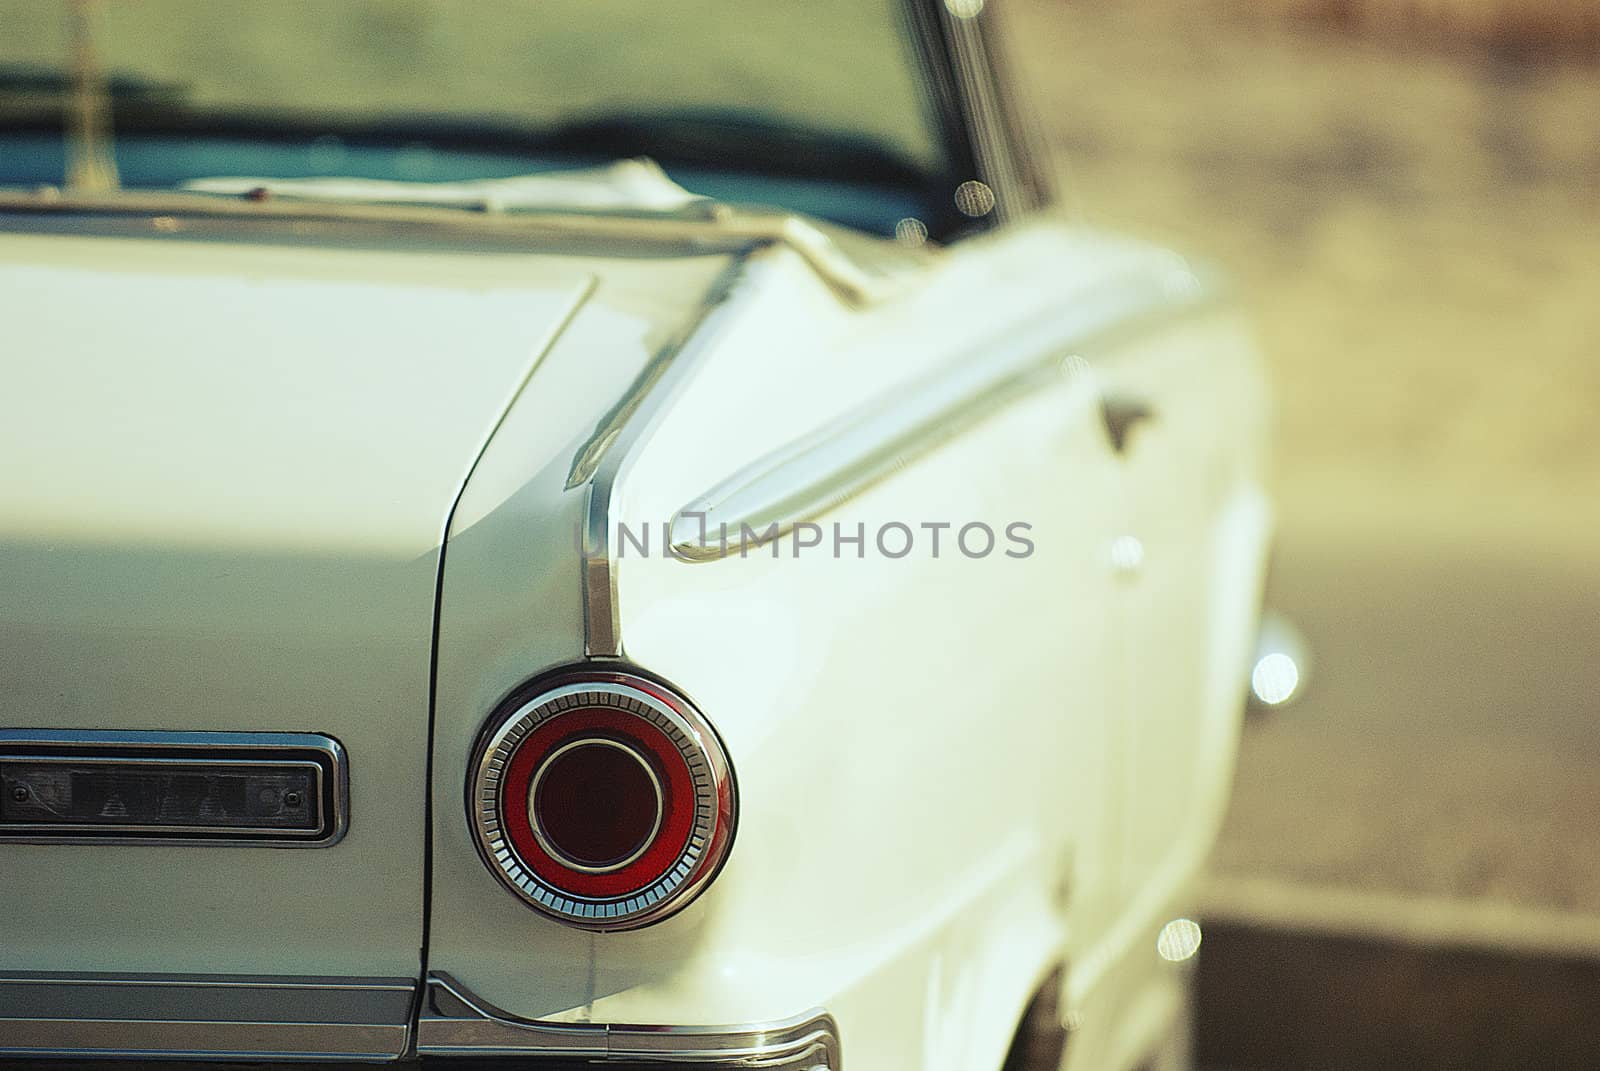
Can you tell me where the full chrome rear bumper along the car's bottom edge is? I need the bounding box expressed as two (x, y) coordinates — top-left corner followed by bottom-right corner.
(0, 972), (840, 1071)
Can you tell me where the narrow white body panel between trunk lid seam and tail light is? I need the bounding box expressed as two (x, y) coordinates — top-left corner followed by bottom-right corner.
(427, 248), (728, 1018)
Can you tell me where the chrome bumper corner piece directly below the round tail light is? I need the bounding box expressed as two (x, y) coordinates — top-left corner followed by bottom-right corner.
(416, 973), (842, 1071)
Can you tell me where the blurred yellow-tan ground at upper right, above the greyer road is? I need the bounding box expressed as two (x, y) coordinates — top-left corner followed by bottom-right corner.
(1011, 0), (1600, 506)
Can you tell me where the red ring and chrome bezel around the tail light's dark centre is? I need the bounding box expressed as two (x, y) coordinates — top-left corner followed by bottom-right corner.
(467, 666), (739, 932)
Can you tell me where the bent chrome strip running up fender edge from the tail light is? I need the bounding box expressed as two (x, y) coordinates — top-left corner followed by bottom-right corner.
(579, 258), (744, 658)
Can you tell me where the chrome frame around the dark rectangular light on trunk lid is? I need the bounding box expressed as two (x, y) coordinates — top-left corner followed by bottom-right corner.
(0, 728), (350, 848)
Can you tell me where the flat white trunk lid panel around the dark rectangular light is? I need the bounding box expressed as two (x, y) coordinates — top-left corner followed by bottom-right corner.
(0, 227), (713, 977)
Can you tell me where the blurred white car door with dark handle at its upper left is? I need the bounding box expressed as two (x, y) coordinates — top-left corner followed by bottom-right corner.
(1099, 289), (1267, 913)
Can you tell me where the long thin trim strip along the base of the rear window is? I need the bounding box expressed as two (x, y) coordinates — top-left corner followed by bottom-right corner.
(0, 187), (931, 306)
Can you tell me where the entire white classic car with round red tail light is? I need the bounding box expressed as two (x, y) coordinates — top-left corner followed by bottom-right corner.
(0, 0), (1269, 1071)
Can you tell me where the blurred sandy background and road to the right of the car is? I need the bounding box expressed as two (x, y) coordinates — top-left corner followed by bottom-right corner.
(1010, 0), (1600, 916)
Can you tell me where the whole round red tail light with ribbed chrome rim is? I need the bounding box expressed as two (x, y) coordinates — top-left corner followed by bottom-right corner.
(470, 672), (738, 930)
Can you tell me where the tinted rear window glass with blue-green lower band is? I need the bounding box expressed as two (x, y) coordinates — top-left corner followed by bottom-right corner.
(0, 0), (965, 232)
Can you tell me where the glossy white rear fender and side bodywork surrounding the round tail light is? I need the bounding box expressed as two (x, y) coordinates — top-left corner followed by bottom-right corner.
(430, 224), (1266, 1068)
